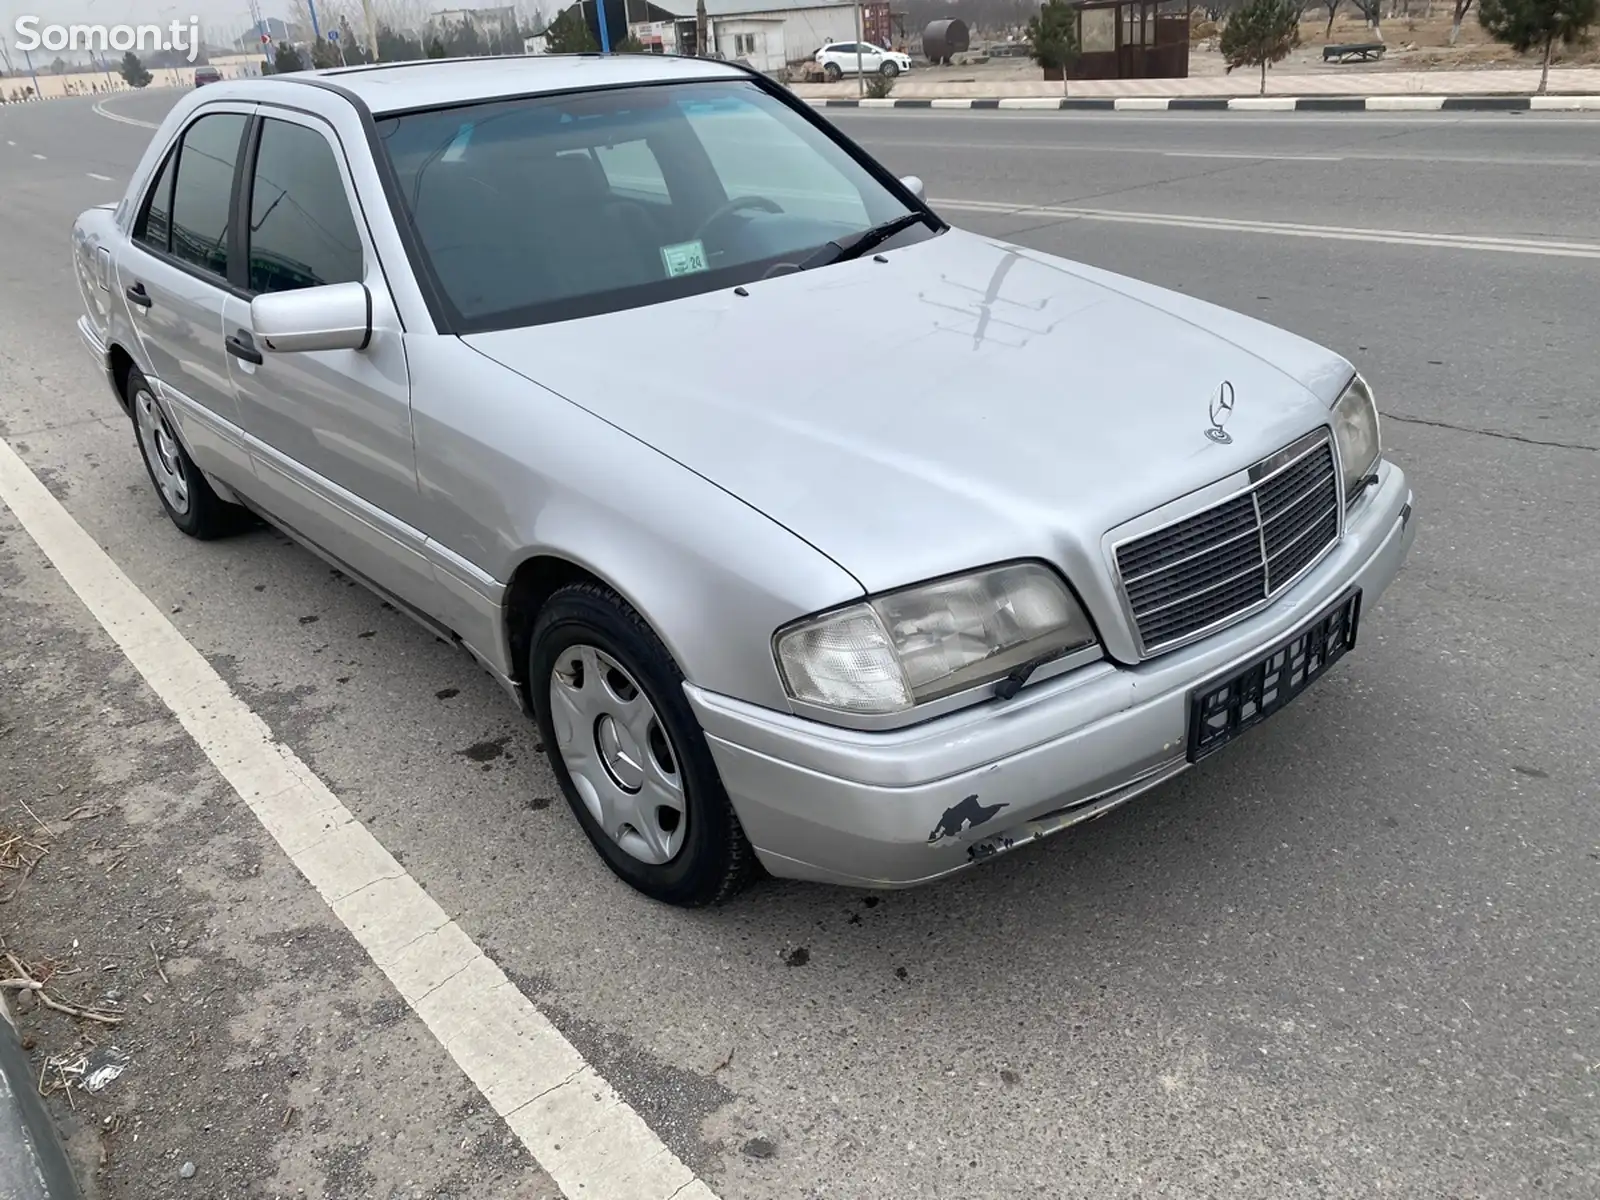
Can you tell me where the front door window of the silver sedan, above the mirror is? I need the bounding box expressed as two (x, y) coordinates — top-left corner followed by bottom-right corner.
(250, 120), (365, 291)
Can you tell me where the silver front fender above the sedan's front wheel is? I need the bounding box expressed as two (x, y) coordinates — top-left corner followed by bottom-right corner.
(406, 334), (862, 710)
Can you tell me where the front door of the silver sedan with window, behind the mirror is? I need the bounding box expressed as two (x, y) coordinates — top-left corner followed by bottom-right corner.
(222, 110), (438, 613)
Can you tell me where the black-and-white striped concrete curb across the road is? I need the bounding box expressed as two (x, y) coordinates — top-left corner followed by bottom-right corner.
(806, 96), (1600, 112)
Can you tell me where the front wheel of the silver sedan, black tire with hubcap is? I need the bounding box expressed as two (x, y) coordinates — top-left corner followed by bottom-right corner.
(528, 584), (755, 907)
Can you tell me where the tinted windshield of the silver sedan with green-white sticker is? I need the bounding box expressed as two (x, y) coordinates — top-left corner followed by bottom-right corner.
(378, 80), (936, 333)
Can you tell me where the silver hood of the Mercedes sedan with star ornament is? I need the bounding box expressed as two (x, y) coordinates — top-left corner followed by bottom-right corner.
(464, 229), (1354, 592)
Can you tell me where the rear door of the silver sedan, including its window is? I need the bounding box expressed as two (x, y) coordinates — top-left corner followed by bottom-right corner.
(115, 104), (254, 480)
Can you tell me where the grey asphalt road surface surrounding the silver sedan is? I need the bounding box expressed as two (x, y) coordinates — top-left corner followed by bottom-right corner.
(0, 94), (1600, 1200)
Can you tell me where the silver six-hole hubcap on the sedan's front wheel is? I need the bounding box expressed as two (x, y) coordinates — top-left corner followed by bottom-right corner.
(550, 645), (688, 866)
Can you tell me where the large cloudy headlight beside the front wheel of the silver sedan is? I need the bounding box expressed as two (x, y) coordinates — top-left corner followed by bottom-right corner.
(774, 563), (1094, 714)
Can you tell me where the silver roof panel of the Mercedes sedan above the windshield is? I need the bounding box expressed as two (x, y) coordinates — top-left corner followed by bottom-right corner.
(253, 54), (749, 115)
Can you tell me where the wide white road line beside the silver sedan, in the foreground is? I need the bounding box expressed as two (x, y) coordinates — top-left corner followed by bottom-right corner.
(0, 440), (717, 1200)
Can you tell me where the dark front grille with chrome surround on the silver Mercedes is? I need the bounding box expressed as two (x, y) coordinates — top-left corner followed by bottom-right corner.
(1117, 435), (1339, 654)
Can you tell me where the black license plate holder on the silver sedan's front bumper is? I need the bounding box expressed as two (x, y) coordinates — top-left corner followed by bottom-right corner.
(1189, 587), (1362, 763)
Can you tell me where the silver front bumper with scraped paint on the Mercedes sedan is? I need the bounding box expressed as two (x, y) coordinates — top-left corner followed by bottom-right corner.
(686, 462), (1416, 886)
